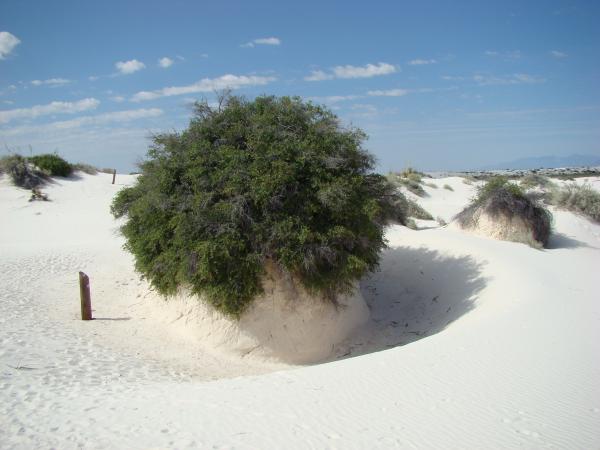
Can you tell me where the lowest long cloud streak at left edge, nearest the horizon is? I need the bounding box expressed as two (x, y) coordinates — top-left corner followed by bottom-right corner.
(0, 108), (163, 136)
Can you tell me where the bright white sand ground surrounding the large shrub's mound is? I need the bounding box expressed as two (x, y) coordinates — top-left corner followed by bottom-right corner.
(0, 171), (600, 448)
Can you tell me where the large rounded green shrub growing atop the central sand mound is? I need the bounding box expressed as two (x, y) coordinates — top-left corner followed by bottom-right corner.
(112, 96), (405, 316)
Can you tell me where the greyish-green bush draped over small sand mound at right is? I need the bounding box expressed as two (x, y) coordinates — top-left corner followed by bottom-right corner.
(455, 176), (552, 246)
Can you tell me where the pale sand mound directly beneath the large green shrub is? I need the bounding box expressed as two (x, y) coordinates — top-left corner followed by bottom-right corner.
(143, 262), (369, 364)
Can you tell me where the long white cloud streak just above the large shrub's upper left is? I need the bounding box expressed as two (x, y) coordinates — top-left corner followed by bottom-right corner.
(131, 74), (276, 102)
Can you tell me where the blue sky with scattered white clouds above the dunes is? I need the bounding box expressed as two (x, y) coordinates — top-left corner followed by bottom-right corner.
(0, 0), (600, 172)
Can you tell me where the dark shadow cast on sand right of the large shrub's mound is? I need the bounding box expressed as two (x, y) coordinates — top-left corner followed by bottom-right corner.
(335, 247), (486, 359)
